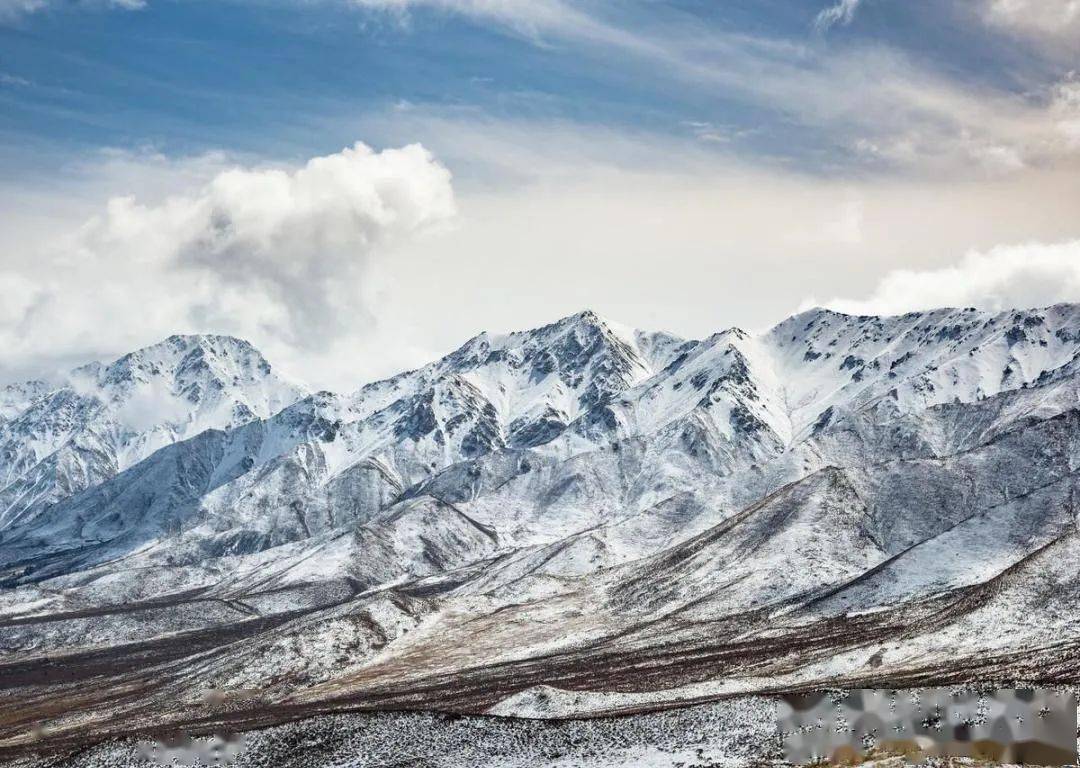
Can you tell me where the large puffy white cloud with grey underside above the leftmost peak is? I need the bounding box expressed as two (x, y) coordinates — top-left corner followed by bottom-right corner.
(0, 144), (455, 384)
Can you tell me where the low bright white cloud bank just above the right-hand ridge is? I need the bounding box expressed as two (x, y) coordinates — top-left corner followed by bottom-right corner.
(805, 240), (1080, 314)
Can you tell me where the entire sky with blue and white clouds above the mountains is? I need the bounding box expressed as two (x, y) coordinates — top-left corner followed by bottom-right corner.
(0, 0), (1080, 390)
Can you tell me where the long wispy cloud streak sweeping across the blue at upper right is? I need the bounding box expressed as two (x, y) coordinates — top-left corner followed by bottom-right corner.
(352, 0), (1080, 175)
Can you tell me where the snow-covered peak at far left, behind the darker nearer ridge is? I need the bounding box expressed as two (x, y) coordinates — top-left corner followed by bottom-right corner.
(0, 336), (301, 530)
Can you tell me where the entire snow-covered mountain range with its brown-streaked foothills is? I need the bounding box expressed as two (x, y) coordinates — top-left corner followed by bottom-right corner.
(0, 305), (1080, 760)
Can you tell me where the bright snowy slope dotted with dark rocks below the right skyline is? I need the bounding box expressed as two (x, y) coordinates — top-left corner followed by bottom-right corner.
(767, 305), (1080, 430)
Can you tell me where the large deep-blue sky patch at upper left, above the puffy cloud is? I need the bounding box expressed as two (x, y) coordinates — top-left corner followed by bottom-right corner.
(0, 0), (727, 157)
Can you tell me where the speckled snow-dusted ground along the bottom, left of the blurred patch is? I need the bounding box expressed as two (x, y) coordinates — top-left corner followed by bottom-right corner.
(0, 699), (778, 768)
